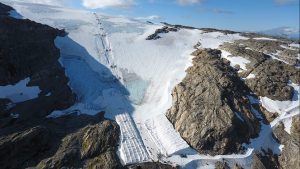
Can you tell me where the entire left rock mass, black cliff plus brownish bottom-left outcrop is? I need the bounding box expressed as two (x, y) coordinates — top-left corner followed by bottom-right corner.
(0, 4), (123, 169)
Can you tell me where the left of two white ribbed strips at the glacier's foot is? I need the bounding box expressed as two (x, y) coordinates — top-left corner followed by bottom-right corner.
(116, 113), (150, 165)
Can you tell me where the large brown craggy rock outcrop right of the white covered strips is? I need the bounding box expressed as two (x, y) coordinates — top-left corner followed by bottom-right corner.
(166, 49), (260, 155)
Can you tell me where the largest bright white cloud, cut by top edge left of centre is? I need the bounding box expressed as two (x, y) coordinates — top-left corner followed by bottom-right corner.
(82, 0), (137, 10)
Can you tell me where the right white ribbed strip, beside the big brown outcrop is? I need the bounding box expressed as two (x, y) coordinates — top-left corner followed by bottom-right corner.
(145, 115), (189, 156)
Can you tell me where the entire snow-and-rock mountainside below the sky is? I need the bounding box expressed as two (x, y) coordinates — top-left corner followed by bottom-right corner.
(0, 0), (300, 169)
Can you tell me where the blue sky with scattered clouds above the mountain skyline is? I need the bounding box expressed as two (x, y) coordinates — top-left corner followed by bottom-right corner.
(18, 0), (299, 31)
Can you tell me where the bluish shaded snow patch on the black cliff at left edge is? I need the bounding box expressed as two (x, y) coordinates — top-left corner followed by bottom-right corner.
(0, 77), (41, 103)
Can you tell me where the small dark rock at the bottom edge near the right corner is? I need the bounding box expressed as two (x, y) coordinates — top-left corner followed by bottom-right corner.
(252, 149), (279, 169)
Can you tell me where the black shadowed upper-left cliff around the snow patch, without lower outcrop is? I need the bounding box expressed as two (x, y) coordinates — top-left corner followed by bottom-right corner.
(0, 10), (76, 120)
